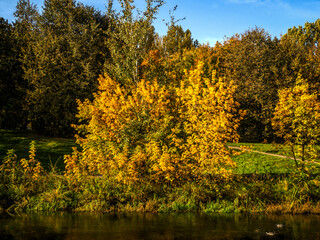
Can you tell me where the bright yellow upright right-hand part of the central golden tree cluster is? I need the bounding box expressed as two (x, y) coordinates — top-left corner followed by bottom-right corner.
(177, 62), (239, 177)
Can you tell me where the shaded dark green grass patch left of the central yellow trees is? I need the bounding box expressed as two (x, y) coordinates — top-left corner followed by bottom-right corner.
(0, 130), (76, 171)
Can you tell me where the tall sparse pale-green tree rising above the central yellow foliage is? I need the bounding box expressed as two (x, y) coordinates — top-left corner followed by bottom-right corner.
(105, 0), (163, 85)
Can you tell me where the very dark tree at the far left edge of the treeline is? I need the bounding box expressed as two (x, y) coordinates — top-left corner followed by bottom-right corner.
(0, 0), (37, 129)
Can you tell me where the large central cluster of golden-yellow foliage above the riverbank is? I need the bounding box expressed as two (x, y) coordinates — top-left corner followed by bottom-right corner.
(65, 56), (242, 184)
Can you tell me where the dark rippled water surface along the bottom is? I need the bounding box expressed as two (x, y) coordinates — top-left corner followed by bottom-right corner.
(0, 213), (320, 240)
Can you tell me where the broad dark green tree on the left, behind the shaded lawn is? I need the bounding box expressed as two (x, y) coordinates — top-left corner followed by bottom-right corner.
(23, 0), (108, 136)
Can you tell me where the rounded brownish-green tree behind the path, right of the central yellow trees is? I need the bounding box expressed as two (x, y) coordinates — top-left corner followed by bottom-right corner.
(213, 28), (281, 142)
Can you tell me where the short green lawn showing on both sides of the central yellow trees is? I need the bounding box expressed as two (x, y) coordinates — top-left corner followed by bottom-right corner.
(0, 130), (320, 174)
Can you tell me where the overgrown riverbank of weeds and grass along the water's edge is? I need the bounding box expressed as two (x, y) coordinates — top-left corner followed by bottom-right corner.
(0, 131), (320, 214)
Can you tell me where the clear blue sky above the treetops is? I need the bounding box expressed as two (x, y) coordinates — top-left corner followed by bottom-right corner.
(0, 0), (320, 45)
